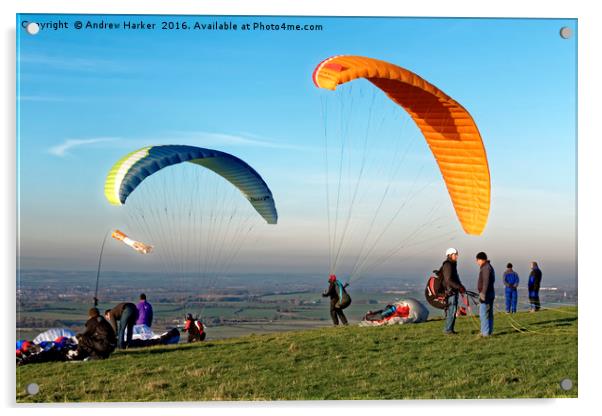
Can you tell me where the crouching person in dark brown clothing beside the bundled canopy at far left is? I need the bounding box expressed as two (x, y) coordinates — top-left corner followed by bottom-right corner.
(75, 308), (116, 360)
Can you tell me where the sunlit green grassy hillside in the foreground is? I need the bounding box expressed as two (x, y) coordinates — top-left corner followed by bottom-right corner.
(16, 308), (577, 402)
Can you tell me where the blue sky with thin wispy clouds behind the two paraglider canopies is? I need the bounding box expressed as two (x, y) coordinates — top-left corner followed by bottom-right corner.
(17, 15), (577, 285)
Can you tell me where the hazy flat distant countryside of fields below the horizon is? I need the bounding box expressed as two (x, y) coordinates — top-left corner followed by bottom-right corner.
(16, 270), (577, 339)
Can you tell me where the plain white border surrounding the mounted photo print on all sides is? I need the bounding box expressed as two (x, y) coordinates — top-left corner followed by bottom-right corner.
(0, 0), (602, 416)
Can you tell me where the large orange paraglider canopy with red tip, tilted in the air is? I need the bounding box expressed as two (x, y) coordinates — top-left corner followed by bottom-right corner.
(313, 55), (491, 235)
